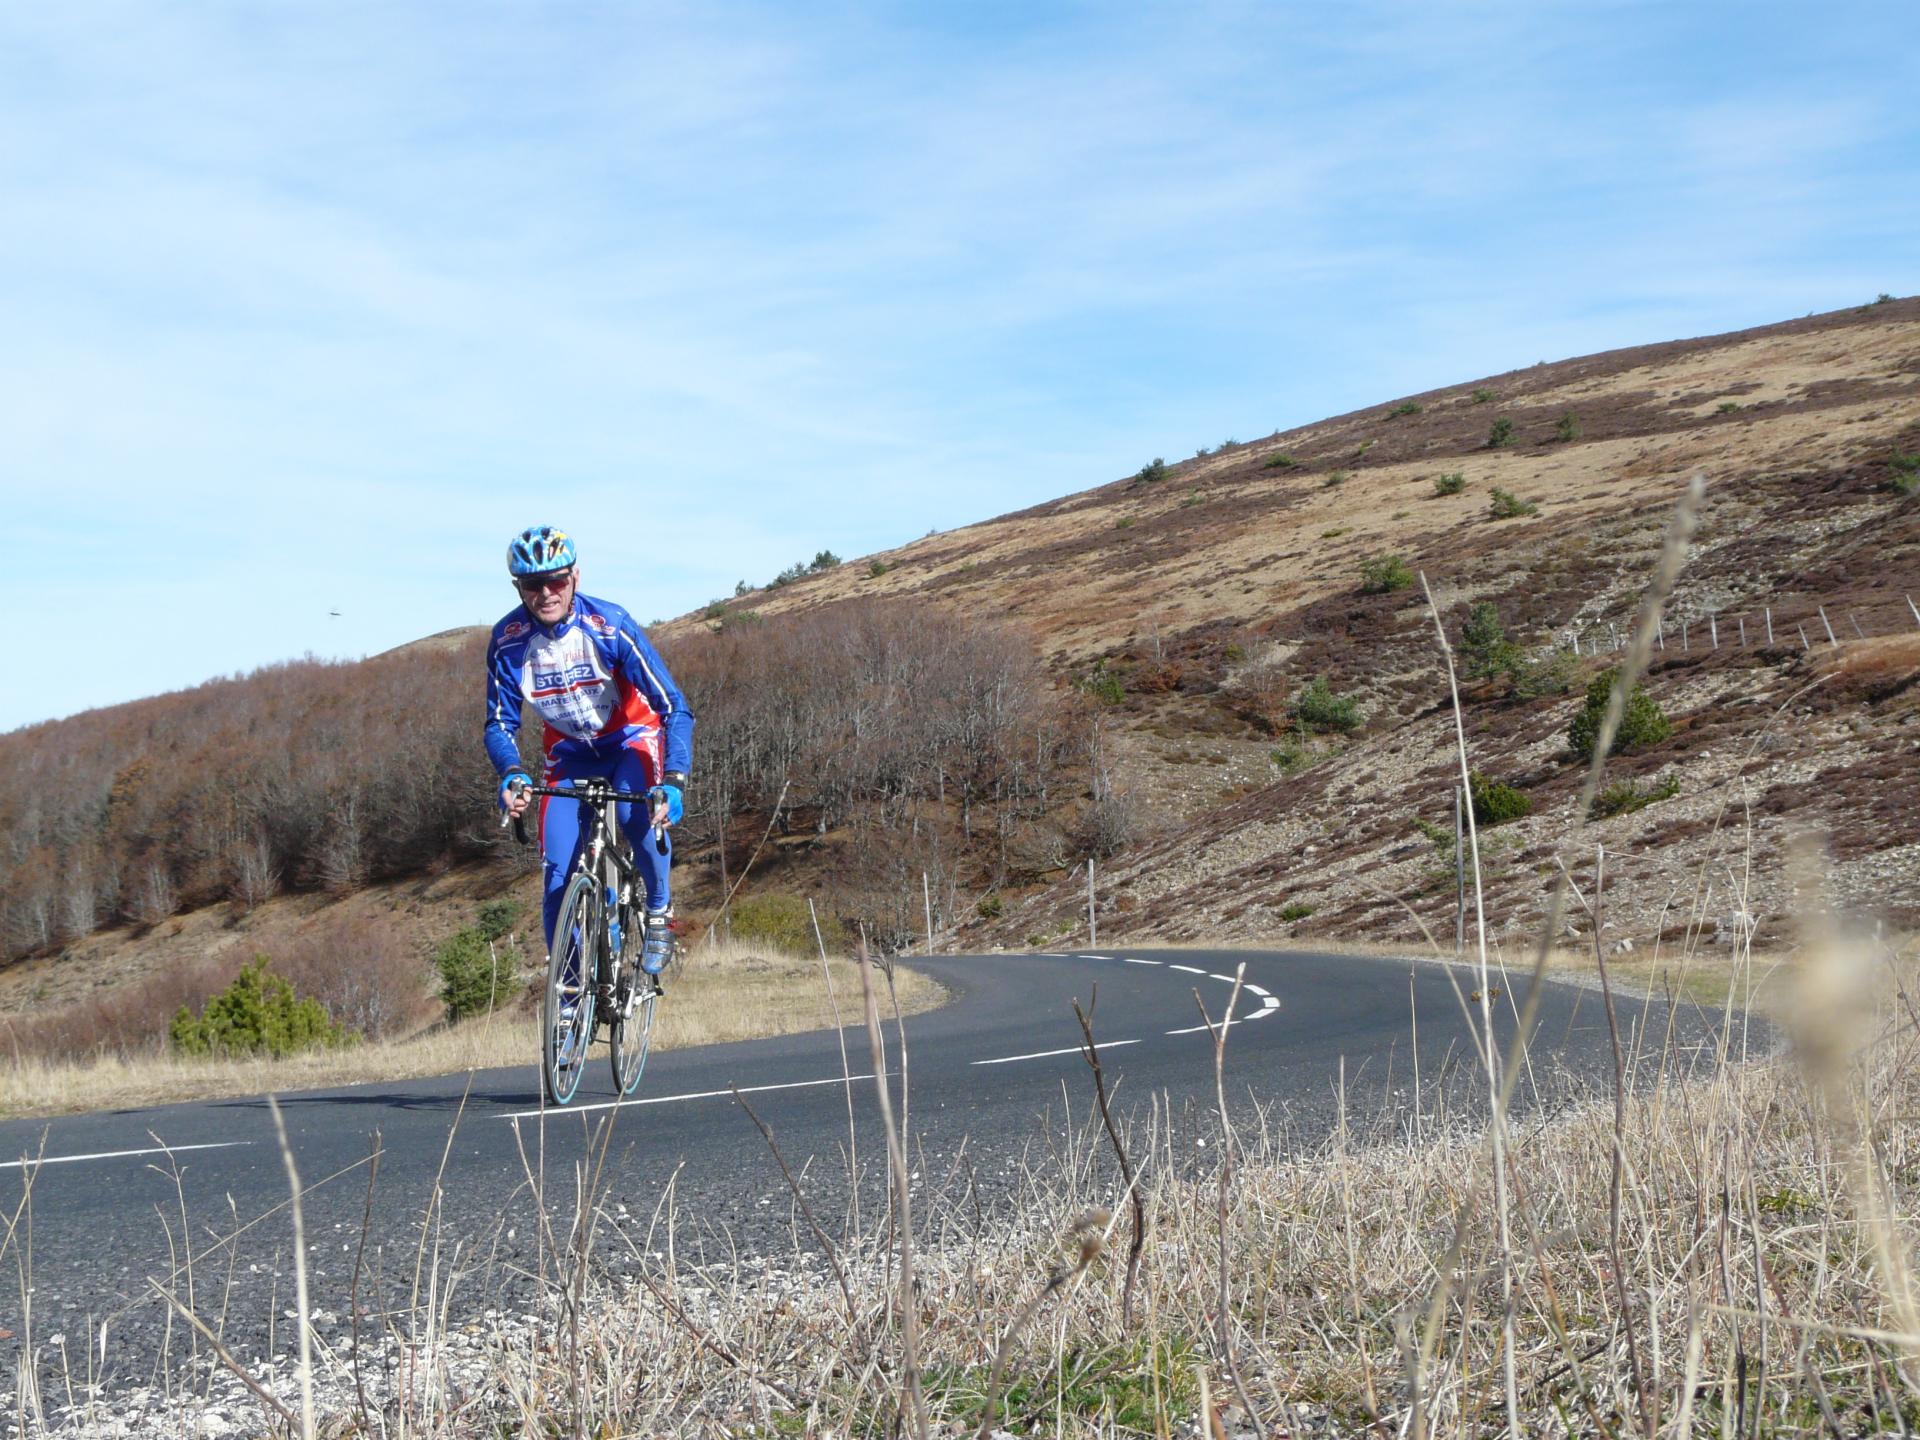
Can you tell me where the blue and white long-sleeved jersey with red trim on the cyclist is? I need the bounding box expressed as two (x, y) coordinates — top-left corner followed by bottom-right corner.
(486, 595), (693, 776)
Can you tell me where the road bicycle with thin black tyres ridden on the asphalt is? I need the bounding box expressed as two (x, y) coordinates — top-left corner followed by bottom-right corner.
(513, 780), (680, 1106)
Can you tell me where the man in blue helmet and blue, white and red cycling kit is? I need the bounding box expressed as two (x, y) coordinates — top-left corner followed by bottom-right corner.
(486, 526), (693, 975)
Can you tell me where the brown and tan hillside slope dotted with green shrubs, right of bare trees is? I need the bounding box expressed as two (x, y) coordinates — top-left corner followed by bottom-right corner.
(668, 300), (1920, 960)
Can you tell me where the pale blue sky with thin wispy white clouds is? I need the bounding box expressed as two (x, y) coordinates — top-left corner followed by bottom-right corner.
(0, 0), (1920, 730)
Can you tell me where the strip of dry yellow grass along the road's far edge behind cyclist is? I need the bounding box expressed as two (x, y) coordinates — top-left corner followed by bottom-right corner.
(0, 943), (945, 1117)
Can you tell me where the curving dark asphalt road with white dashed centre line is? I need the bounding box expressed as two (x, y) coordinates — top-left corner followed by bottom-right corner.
(0, 950), (1743, 1384)
